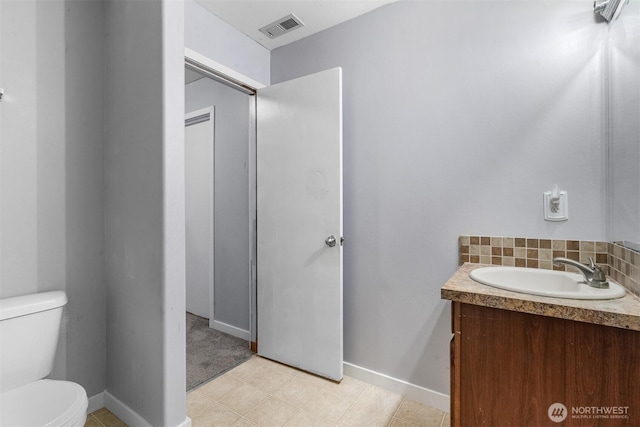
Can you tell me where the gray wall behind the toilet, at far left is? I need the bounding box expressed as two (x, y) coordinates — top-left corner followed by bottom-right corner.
(0, 1), (106, 396)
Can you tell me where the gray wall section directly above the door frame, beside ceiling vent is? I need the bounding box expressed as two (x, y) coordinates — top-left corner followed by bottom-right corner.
(184, 0), (271, 85)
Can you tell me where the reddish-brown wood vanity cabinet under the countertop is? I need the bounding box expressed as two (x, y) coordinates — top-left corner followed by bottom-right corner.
(451, 301), (640, 427)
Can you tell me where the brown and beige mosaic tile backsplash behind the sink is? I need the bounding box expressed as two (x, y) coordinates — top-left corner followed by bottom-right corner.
(458, 236), (640, 296)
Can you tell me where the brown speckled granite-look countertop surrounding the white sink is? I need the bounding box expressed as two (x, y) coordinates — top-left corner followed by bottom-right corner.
(440, 263), (640, 331)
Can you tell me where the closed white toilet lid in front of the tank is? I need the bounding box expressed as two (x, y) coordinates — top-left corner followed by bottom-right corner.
(0, 380), (88, 427)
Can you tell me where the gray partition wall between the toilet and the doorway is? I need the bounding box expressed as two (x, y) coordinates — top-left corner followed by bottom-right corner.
(105, 1), (186, 426)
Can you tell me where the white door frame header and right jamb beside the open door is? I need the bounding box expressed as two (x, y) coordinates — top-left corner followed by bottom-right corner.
(184, 47), (267, 351)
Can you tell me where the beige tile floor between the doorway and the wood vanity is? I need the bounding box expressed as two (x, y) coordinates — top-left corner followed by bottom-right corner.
(187, 356), (450, 427)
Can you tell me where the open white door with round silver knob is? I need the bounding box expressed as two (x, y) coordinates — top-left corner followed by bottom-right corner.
(256, 68), (343, 380)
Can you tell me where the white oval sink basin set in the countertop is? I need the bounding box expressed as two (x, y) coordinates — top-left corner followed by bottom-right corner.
(469, 267), (626, 299)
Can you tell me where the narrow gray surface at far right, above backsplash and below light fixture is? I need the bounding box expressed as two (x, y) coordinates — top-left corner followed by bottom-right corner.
(608, 0), (640, 247)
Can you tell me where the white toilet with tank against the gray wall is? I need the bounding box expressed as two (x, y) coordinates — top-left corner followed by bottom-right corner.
(0, 291), (88, 427)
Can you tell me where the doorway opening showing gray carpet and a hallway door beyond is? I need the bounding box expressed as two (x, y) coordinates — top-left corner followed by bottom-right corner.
(185, 51), (255, 390)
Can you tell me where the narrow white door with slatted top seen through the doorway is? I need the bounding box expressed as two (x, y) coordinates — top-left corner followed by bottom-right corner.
(184, 107), (214, 324)
